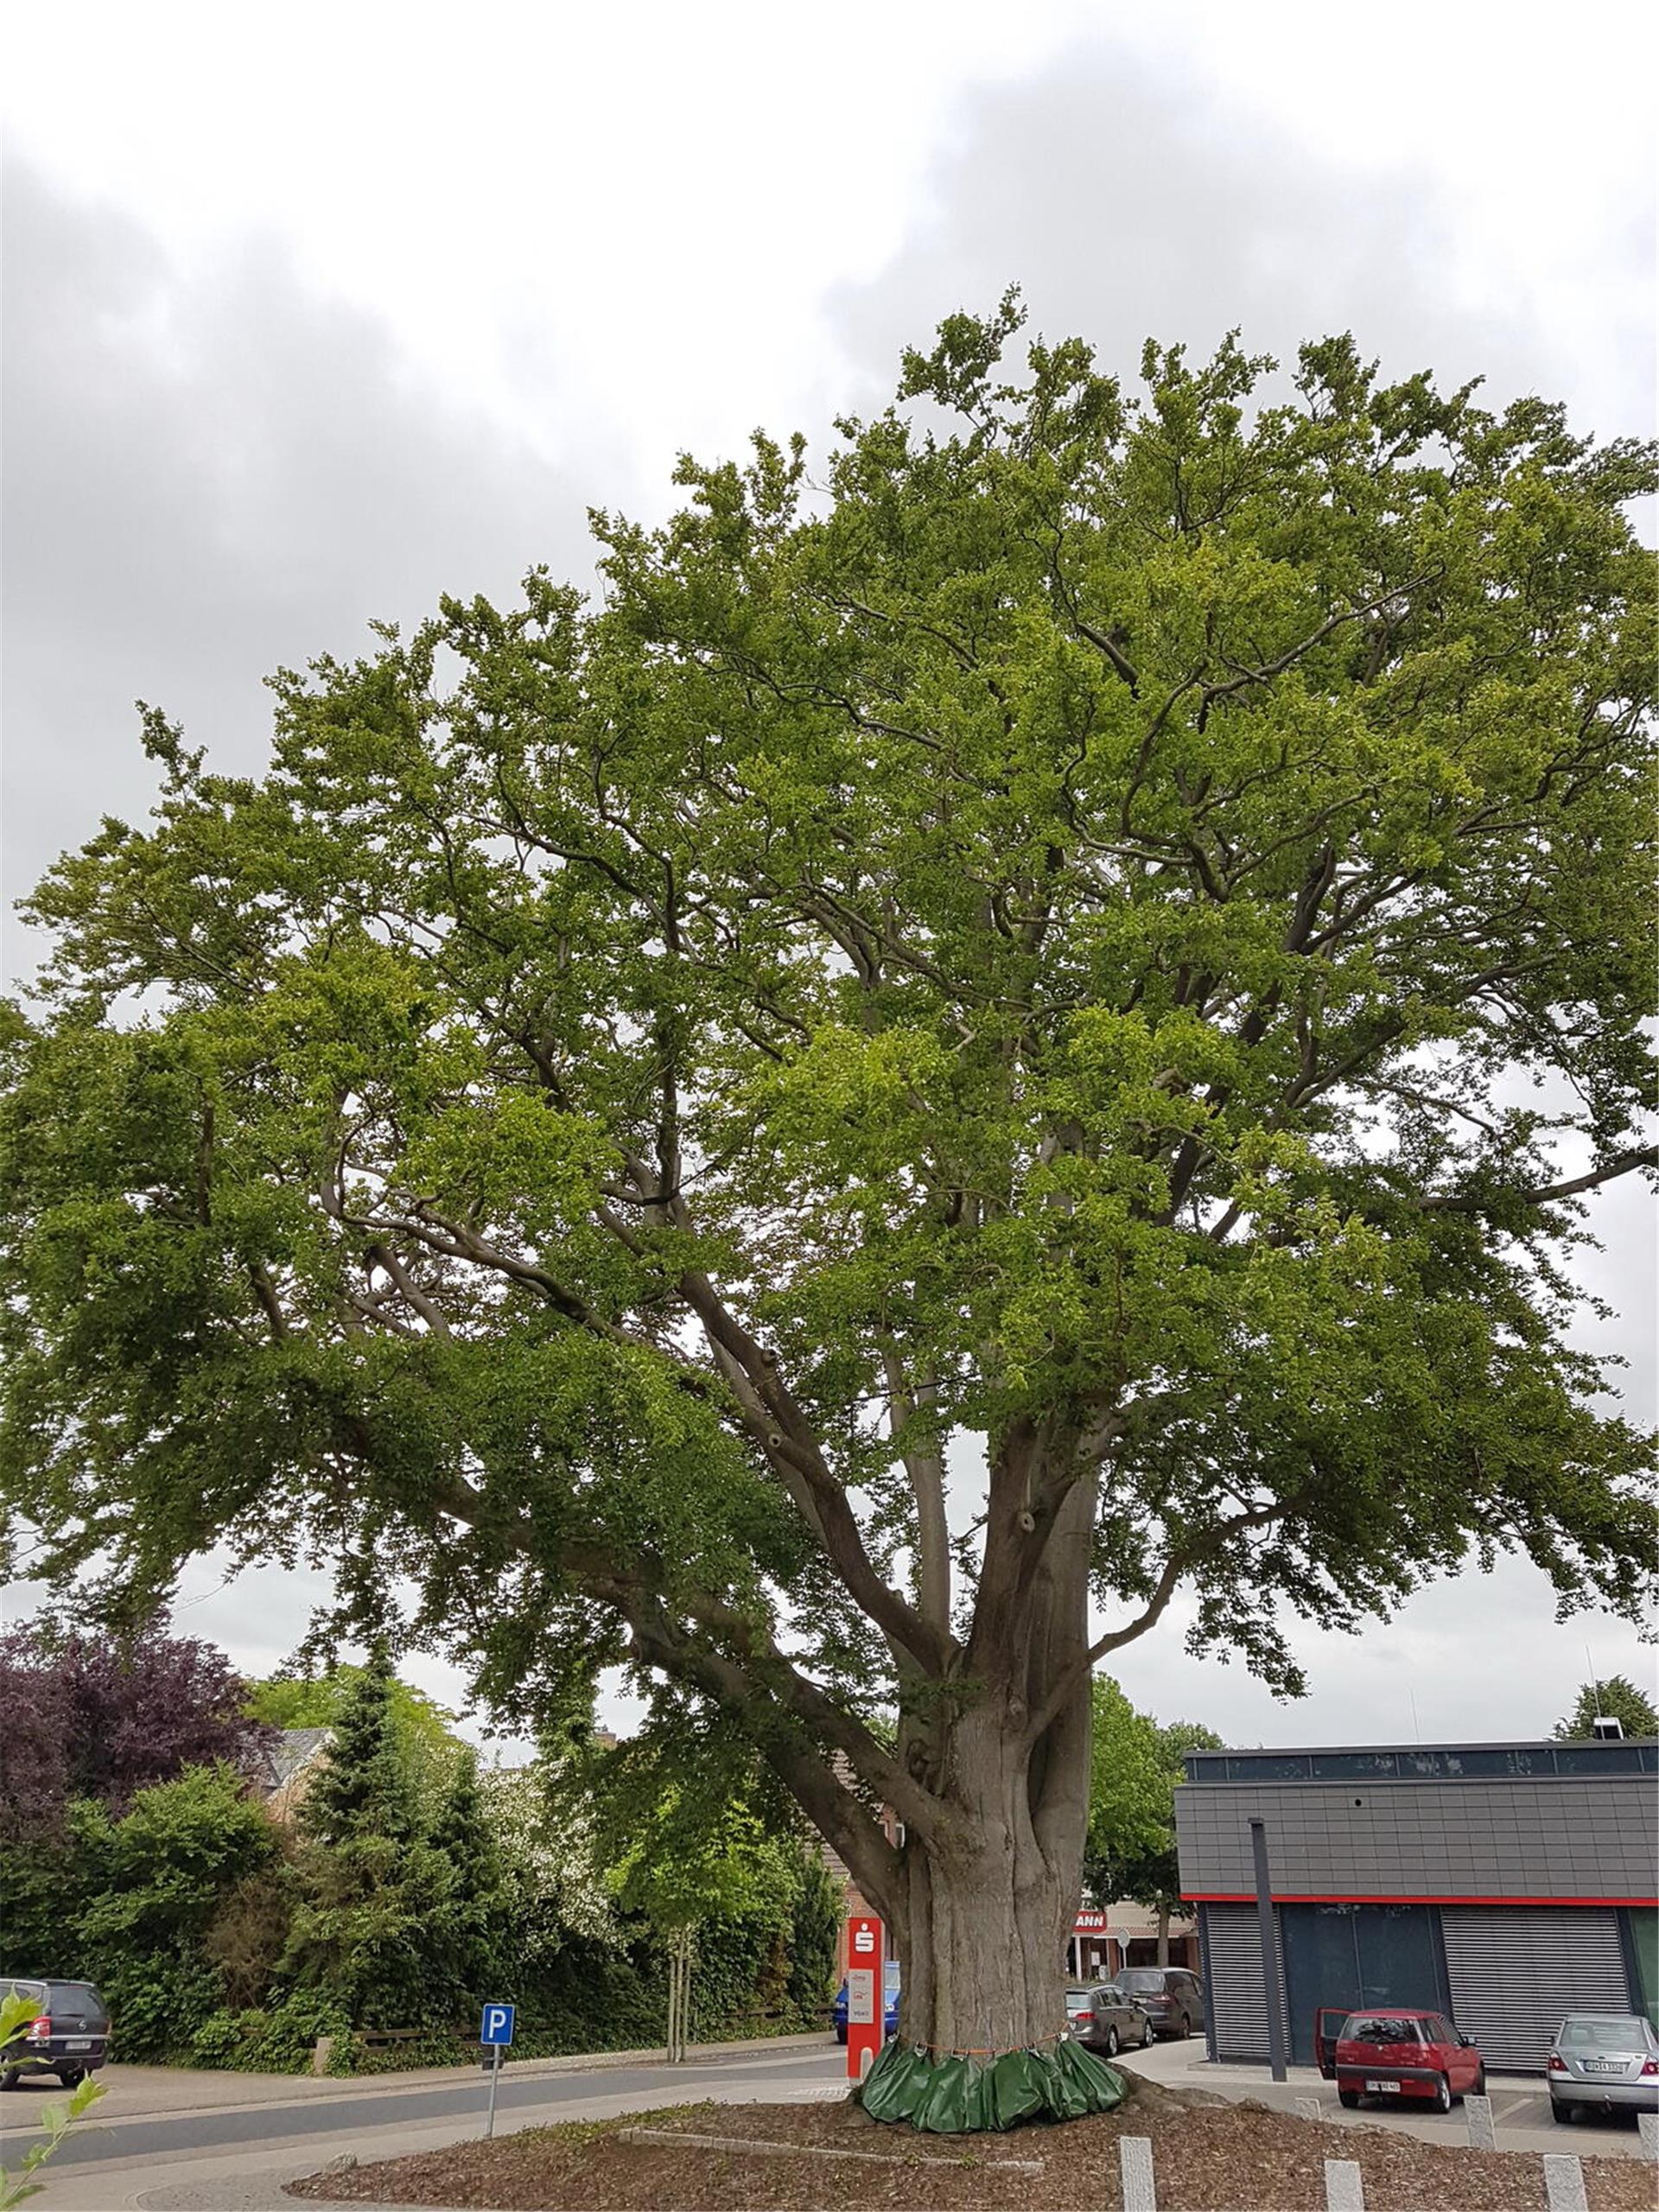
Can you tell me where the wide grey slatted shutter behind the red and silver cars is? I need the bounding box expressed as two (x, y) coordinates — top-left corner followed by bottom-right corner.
(1440, 1904), (1632, 2073)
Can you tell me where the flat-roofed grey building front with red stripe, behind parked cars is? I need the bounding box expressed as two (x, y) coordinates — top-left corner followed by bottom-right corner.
(1174, 1741), (1659, 2073)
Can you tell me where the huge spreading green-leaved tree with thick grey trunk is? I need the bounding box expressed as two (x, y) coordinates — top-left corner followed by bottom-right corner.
(0, 303), (1655, 2050)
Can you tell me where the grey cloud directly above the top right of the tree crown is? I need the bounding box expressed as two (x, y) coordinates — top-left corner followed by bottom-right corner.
(832, 47), (1655, 435)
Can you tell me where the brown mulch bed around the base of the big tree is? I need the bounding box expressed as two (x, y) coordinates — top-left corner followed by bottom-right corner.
(288, 2082), (1655, 2212)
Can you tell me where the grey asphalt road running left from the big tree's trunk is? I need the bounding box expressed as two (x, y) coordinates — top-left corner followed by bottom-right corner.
(0, 2044), (847, 2174)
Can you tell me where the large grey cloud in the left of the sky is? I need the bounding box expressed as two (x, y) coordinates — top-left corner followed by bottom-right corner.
(3, 163), (588, 963)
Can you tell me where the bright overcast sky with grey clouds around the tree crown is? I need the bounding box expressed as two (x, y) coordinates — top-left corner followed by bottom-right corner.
(0, 0), (1659, 1743)
